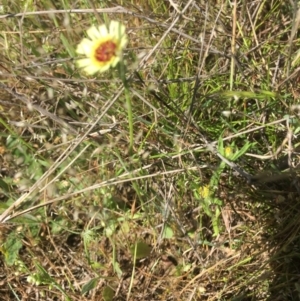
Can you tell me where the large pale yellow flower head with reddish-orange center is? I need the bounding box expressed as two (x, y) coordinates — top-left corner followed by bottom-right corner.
(76, 21), (128, 75)
